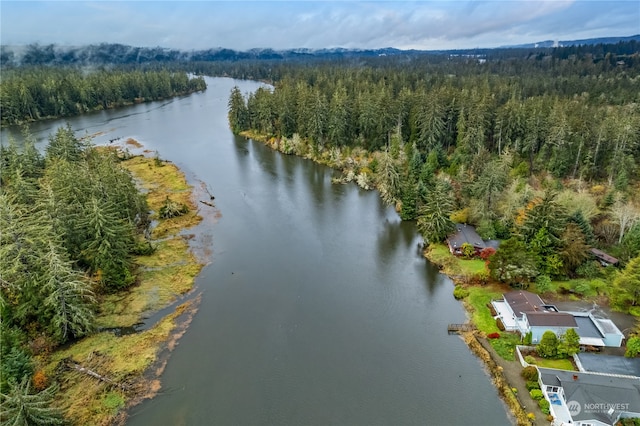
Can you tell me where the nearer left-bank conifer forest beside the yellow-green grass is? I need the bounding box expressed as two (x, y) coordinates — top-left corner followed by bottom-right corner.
(0, 127), (151, 424)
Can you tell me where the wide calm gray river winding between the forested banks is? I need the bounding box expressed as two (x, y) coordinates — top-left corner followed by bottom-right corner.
(2, 78), (511, 425)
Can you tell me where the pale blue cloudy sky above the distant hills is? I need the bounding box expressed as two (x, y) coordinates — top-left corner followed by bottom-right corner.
(0, 0), (640, 51)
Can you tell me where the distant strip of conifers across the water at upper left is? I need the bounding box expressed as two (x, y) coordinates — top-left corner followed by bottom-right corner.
(0, 67), (206, 126)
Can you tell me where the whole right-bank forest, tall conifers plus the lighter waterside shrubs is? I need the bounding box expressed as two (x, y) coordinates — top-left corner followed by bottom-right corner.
(229, 40), (640, 308)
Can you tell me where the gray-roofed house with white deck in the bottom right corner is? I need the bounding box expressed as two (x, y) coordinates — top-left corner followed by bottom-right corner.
(536, 367), (640, 426)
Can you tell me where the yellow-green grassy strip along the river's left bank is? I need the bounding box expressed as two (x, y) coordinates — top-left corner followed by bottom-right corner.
(39, 147), (203, 425)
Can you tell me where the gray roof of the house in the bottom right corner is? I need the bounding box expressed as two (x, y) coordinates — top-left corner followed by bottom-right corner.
(538, 368), (640, 424)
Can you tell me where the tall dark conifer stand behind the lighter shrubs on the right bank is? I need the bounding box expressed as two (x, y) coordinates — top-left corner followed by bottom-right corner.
(230, 60), (640, 181)
